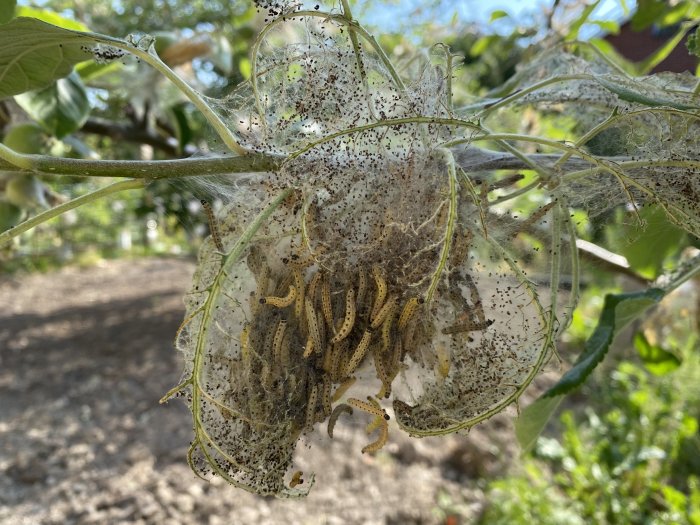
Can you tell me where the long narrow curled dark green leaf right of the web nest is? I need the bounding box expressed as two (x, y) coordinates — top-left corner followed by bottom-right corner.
(515, 288), (666, 452)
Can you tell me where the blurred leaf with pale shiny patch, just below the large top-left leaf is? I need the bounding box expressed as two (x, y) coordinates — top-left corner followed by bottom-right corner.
(15, 73), (90, 138)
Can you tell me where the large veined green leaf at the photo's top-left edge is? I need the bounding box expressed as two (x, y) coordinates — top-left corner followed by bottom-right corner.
(0, 18), (95, 99)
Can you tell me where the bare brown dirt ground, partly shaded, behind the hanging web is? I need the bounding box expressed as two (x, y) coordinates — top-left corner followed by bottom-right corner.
(0, 259), (556, 525)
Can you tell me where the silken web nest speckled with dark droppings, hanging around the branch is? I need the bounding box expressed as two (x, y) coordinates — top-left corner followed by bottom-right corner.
(165, 4), (698, 497)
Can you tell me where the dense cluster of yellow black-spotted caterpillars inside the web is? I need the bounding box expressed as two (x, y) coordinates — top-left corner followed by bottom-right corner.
(240, 245), (424, 452)
